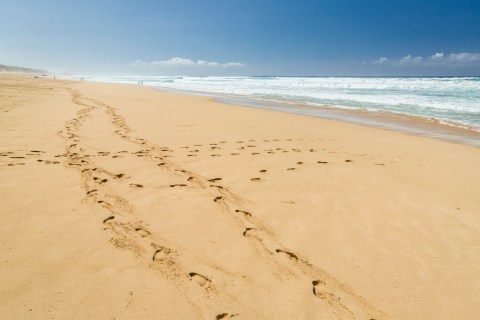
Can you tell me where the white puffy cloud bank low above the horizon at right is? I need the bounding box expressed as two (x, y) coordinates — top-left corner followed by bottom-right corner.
(373, 52), (480, 66)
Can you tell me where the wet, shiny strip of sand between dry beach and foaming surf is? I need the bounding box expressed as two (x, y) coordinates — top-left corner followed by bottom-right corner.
(154, 85), (480, 147)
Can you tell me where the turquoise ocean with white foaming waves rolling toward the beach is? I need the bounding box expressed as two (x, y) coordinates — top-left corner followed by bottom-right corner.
(92, 76), (480, 132)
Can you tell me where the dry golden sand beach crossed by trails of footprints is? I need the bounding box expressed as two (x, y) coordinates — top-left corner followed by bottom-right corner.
(0, 75), (480, 320)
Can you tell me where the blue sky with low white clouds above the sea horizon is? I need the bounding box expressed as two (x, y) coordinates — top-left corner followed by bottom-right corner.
(0, 0), (480, 75)
